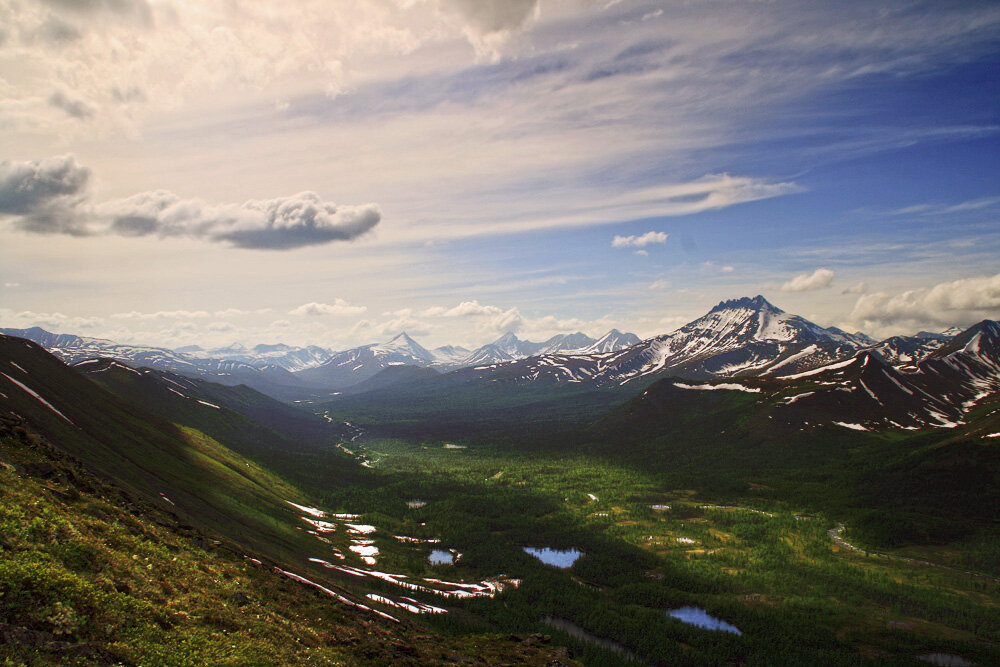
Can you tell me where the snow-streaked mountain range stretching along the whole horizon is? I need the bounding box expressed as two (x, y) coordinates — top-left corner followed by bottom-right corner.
(0, 295), (994, 427)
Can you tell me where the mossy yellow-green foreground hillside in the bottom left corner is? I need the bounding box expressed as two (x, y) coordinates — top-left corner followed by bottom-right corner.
(0, 419), (573, 667)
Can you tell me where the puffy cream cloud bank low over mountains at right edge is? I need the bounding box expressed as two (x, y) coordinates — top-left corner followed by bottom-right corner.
(850, 273), (1000, 328)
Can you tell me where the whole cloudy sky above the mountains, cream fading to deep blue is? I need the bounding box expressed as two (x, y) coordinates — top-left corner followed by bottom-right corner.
(0, 0), (1000, 349)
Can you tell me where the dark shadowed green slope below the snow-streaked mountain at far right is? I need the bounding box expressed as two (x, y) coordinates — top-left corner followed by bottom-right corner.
(583, 380), (1000, 560)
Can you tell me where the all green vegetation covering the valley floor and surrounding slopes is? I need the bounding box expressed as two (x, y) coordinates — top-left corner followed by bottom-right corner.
(0, 339), (1000, 665)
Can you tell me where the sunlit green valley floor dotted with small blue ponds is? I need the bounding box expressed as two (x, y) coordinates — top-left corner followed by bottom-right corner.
(324, 439), (1000, 665)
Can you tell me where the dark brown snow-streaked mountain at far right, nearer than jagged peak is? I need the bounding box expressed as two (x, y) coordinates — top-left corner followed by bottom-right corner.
(612, 320), (1000, 432)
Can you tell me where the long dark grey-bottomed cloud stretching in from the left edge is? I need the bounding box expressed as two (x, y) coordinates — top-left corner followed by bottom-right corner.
(0, 155), (382, 250)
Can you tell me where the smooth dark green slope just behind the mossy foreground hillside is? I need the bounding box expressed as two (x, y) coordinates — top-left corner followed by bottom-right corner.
(0, 336), (324, 568)
